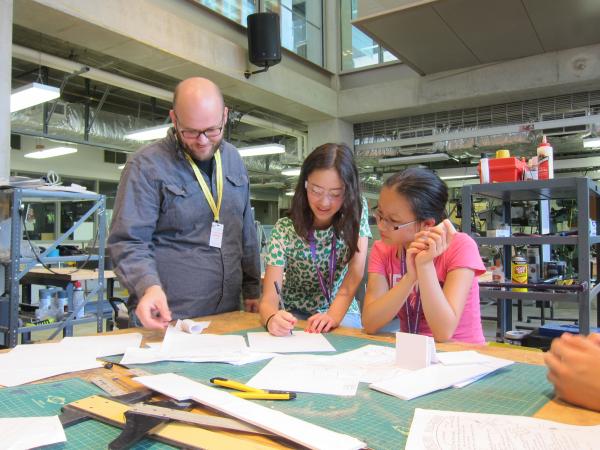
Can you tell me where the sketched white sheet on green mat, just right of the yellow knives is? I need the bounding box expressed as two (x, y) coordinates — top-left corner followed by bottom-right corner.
(247, 355), (361, 396)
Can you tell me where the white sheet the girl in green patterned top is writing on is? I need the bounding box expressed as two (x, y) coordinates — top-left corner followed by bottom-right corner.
(248, 331), (335, 353)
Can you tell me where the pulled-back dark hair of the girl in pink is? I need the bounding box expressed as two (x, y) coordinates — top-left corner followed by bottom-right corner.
(384, 167), (448, 224)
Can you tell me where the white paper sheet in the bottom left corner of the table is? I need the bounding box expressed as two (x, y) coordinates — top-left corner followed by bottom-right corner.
(0, 416), (67, 450)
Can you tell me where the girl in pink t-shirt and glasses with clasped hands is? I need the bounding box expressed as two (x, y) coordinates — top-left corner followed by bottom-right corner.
(362, 168), (485, 344)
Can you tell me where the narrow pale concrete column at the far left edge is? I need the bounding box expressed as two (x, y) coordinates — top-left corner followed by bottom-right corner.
(0, 0), (13, 178)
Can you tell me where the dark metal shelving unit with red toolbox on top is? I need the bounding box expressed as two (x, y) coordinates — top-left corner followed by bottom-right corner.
(462, 177), (600, 339)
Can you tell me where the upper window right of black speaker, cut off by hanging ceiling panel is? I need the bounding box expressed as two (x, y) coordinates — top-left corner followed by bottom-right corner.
(340, 0), (397, 70)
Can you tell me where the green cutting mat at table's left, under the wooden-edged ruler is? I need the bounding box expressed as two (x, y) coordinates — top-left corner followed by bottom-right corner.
(0, 378), (174, 450)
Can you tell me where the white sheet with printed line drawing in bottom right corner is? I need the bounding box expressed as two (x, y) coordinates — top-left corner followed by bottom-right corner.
(405, 408), (600, 450)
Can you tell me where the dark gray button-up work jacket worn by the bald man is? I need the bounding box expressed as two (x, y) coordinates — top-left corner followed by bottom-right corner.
(108, 129), (260, 319)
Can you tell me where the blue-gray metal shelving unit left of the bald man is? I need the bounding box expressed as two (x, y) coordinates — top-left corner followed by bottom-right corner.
(0, 188), (108, 347)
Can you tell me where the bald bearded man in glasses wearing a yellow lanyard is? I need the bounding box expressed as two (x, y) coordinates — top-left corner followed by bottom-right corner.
(108, 78), (260, 328)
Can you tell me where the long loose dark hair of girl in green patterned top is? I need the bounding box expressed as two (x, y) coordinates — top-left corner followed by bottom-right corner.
(290, 144), (362, 262)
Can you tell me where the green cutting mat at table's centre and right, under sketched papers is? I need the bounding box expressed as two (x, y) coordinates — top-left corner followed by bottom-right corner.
(115, 330), (553, 450)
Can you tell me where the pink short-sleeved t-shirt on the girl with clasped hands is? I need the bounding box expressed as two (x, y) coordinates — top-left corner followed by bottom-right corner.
(369, 233), (485, 344)
